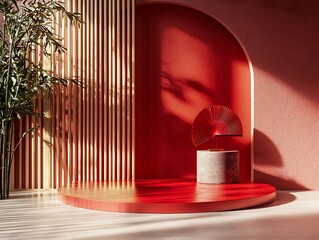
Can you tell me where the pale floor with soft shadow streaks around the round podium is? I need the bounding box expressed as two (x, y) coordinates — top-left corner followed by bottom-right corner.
(0, 190), (319, 240)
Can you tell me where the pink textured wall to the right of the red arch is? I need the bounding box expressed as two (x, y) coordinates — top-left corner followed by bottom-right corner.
(137, 0), (319, 189)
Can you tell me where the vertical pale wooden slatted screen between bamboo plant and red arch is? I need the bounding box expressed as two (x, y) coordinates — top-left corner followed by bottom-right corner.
(12, 0), (135, 189)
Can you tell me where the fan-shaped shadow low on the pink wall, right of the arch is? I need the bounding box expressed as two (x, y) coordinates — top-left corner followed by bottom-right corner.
(254, 129), (308, 190)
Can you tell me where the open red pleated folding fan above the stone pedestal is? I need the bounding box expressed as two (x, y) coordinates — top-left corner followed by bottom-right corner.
(192, 105), (243, 147)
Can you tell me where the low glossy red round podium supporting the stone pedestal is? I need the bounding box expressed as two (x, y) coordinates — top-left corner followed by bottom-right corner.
(58, 179), (276, 213)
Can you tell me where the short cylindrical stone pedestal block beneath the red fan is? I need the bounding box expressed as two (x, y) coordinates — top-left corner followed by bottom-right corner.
(197, 150), (239, 184)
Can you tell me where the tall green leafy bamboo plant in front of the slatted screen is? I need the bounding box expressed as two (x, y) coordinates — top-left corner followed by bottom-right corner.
(0, 0), (82, 199)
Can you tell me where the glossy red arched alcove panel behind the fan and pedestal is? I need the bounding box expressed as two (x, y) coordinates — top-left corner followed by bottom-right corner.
(135, 4), (251, 181)
